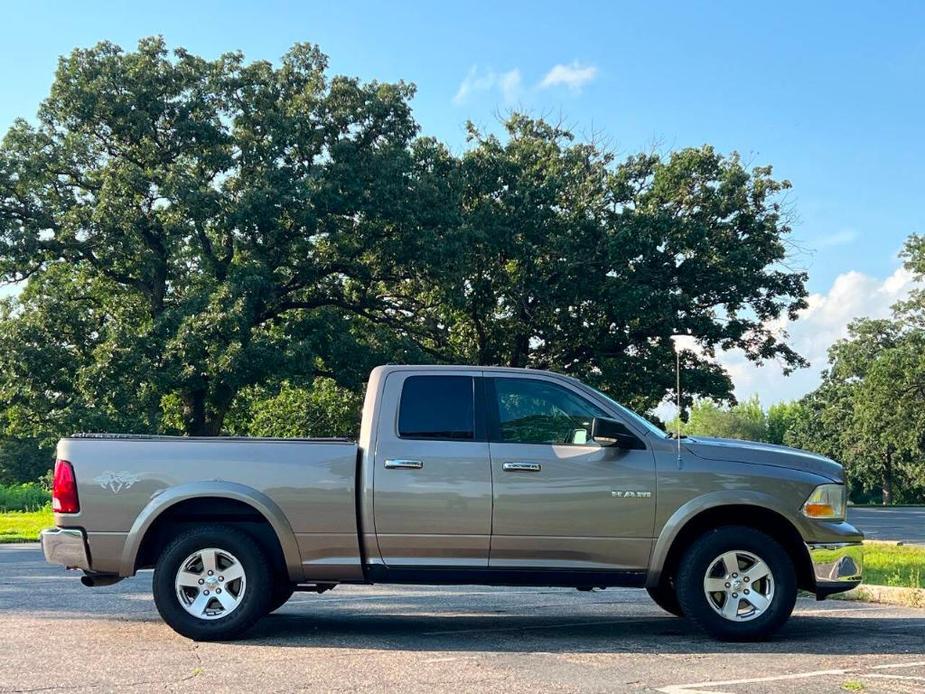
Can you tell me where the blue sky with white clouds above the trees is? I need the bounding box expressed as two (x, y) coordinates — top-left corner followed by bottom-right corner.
(0, 0), (925, 402)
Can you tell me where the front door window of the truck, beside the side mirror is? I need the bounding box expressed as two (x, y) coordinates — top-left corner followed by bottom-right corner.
(494, 378), (607, 445)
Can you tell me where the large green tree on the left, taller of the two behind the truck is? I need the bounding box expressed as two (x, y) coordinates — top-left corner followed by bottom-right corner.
(0, 39), (449, 435)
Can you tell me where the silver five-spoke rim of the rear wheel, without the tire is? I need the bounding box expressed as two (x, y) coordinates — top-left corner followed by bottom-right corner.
(174, 547), (247, 620)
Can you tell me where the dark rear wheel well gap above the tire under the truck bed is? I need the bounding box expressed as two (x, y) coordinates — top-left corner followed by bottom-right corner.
(135, 497), (286, 575)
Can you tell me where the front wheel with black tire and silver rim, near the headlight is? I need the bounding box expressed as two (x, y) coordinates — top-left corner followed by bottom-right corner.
(675, 526), (797, 641)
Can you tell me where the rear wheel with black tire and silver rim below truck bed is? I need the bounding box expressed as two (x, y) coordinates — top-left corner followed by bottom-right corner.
(154, 525), (273, 641)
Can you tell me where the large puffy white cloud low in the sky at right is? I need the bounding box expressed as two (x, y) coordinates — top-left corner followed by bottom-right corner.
(717, 267), (915, 406)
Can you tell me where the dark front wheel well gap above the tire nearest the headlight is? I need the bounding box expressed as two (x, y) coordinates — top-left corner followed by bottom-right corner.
(662, 504), (816, 591)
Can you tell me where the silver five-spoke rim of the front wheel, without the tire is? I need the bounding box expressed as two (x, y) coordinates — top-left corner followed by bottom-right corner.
(703, 550), (774, 622)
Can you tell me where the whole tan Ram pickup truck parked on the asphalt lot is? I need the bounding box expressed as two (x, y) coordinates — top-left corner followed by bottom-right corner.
(42, 366), (863, 640)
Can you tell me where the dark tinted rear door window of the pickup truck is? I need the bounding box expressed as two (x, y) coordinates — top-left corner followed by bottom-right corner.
(398, 376), (475, 440)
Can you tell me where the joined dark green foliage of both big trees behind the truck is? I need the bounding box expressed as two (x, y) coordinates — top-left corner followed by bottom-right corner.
(0, 38), (806, 468)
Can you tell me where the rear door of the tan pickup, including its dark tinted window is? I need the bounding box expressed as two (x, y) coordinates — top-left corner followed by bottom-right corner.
(373, 369), (492, 568)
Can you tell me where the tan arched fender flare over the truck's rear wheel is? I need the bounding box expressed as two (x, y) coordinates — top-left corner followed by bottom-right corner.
(119, 481), (304, 582)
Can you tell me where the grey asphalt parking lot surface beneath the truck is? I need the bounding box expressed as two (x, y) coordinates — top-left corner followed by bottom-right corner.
(0, 545), (925, 694)
